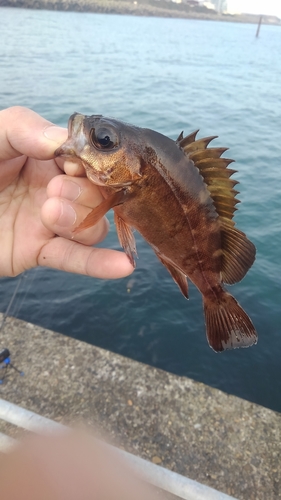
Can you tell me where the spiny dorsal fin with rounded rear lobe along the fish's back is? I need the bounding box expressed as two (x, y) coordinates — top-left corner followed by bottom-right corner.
(177, 131), (256, 284)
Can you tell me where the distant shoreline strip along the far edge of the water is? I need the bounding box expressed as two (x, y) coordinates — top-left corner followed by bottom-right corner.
(0, 0), (281, 26)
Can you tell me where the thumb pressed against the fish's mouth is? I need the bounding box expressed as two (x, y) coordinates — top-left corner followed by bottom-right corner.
(0, 106), (67, 160)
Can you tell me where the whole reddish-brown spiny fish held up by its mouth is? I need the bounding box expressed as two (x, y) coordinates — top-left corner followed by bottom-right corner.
(55, 113), (257, 352)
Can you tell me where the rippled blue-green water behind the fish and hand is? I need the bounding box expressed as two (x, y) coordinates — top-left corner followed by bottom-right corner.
(0, 8), (281, 411)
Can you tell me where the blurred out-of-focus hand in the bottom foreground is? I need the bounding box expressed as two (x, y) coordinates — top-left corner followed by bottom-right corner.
(0, 431), (164, 500)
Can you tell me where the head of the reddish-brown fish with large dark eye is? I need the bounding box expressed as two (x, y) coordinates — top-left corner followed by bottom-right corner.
(55, 113), (141, 188)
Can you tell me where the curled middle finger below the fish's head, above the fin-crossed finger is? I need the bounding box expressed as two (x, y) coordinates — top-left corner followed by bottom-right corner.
(47, 175), (104, 208)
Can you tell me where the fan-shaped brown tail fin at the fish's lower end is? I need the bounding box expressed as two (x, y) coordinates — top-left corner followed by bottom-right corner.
(204, 290), (258, 351)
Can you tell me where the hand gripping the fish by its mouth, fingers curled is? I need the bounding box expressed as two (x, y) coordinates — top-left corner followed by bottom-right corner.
(0, 107), (133, 278)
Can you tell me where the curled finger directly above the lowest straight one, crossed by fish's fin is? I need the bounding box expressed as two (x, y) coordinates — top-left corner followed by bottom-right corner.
(41, 198), (109, 245)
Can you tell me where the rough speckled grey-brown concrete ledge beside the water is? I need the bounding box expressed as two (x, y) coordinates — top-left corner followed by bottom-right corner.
(0, 318), (281, 500)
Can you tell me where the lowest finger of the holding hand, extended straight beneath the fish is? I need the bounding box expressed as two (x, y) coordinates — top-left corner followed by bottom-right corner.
(38, 237), (134, 279)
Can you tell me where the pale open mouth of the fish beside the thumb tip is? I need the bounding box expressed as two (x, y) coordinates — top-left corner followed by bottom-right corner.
(55, 113), (86, 158)
